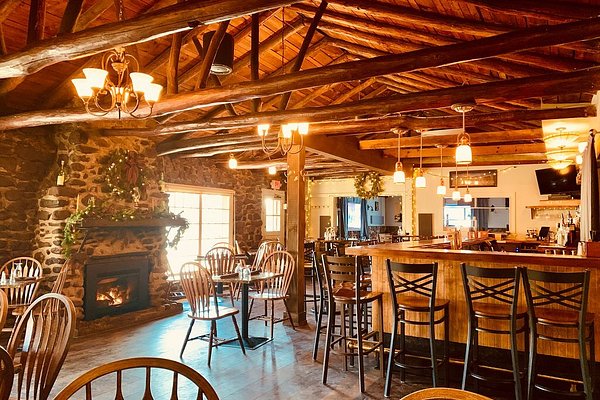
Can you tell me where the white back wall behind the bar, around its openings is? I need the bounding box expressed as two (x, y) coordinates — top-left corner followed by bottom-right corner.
(311, 164), (558, 236)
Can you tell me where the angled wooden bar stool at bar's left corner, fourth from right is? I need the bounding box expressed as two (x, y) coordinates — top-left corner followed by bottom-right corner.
(322, 255), (383, 393)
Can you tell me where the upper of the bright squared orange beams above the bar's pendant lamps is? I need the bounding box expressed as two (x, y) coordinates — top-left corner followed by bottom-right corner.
(360, 128), (542, 150)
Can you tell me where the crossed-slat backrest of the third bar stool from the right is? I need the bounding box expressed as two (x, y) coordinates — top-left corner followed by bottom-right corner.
(386, 259), (438, 315)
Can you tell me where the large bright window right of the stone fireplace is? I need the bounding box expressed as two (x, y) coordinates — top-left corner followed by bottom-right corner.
(167, 185), (233, 271)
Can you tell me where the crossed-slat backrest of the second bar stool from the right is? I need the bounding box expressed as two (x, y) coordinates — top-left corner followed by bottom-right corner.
(460, 263), (521, 315)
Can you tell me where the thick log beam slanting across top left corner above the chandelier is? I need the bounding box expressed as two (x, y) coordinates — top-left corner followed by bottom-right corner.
(0, 0), (293, 78)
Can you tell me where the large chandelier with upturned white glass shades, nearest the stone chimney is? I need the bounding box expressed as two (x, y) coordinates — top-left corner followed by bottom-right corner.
(71, 47), (162, 119)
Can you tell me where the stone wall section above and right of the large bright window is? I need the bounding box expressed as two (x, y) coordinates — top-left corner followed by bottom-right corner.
(157, 157), (272, 249)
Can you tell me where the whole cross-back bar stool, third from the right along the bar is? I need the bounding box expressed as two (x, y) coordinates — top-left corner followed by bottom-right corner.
(384, 259), (450, 397)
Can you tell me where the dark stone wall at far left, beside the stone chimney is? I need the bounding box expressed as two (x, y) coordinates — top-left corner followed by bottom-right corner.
(0, 130), (58, 265)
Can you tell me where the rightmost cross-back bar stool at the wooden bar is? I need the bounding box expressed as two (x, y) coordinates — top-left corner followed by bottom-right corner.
(523, 269), (596, 400)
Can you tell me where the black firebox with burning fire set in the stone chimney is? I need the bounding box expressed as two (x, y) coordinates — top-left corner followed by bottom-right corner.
(84, 253), (150, 320)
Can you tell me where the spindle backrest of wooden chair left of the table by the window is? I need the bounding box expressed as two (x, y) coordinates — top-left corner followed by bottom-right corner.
(180, 262), (219, 315)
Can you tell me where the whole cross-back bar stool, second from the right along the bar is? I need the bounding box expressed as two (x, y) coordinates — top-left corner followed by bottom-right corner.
(460, 263), (528, 400)
